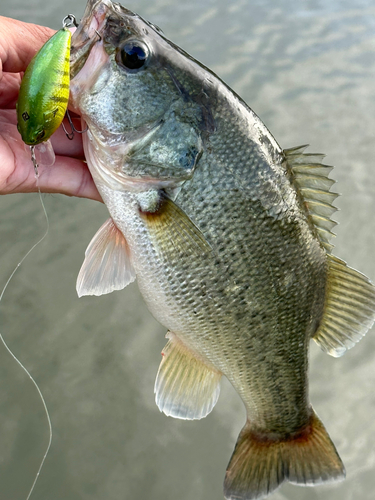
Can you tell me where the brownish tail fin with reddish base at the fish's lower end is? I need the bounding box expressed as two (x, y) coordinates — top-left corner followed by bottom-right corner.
(224, 412), (345, 500)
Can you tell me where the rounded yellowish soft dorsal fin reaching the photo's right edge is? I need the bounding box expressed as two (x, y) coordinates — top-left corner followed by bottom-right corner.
(313, 255), (375, 357)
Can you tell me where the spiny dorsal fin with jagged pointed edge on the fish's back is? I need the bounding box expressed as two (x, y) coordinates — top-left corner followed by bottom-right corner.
(284, 146), (338, 253)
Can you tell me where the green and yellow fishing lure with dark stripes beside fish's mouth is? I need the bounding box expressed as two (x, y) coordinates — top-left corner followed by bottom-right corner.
(16, 14), (77, 146)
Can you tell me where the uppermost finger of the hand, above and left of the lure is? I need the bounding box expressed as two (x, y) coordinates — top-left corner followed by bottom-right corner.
(0, 16), (55, 73)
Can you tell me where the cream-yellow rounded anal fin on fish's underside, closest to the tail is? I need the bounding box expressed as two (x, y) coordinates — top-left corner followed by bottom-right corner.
(155, 332), (221, 420)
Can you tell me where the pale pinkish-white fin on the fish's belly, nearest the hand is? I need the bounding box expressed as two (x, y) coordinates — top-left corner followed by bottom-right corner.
(77, 218), (135, 297)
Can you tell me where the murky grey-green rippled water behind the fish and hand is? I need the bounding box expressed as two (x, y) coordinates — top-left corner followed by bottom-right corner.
(0, 0), (375, 500)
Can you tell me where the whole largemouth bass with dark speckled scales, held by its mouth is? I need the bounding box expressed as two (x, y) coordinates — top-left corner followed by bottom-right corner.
(70, 0), (375, 500)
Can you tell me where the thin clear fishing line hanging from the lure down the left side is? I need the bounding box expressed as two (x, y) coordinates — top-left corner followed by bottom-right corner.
(0, 154), (52, 500)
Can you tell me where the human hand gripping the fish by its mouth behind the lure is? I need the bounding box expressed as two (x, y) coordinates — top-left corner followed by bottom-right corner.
(0, 16), (101, 201)
